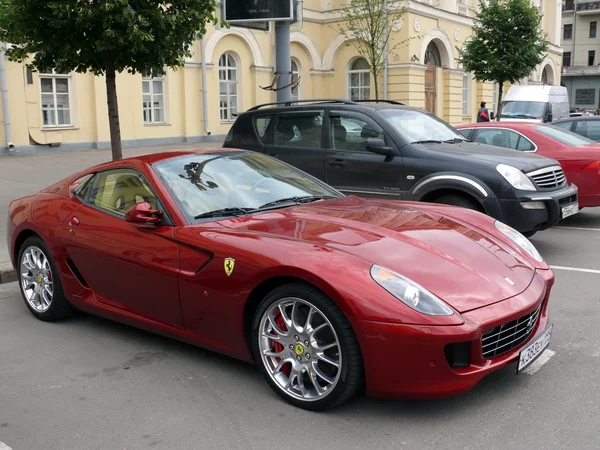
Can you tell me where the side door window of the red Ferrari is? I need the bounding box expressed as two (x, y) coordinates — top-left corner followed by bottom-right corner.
(88, 169), (158, 216)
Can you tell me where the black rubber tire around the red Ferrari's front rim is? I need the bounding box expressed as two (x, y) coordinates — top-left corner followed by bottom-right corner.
(252, 282), (364, 411)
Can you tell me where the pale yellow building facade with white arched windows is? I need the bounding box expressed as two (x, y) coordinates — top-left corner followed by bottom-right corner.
(0, 0), (562, 153)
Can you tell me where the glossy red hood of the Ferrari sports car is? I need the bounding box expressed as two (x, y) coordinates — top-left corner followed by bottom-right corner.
(222, 197), (535, 312)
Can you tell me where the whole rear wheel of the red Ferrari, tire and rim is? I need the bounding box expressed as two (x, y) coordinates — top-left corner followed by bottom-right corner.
(18, 236), (73, 322)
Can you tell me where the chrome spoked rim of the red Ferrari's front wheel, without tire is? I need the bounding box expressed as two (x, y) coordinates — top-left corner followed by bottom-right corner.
(258, 298), (342, 401)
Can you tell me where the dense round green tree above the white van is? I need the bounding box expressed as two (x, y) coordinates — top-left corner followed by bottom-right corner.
(458, 0), (548, 118)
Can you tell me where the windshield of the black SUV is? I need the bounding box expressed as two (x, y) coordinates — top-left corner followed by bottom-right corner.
(381, 109), (466, 143)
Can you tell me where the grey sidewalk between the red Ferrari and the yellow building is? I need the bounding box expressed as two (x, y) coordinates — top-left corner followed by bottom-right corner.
(0, 142), (220, 283)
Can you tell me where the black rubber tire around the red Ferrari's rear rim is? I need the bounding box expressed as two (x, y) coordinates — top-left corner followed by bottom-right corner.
(17, 236), (73, 322)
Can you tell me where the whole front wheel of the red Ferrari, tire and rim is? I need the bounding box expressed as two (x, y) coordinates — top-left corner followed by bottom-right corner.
(252, 283), (363, 410)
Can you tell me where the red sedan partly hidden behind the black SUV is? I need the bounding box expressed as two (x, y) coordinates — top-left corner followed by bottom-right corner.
(456, 122), (600, 208)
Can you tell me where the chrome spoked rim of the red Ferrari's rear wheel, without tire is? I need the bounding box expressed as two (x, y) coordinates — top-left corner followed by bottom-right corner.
(20, 245), (54, 313)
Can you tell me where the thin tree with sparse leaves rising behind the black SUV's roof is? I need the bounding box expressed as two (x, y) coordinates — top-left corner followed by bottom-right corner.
(334, 0), (410, 99)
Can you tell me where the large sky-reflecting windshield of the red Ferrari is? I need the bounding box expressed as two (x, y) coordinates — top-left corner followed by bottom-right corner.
(153, 152), (341, 220)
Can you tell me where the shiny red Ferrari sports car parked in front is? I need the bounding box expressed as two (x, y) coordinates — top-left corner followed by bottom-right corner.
(8, 149), (554, 410)
